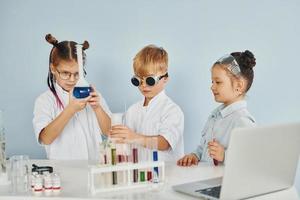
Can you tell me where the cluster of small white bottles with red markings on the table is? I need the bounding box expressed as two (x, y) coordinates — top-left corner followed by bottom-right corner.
(31, 171), (61, 196)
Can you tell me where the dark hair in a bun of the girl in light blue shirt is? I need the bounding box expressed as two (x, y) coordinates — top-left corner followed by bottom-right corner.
(231, 50), (256, 92)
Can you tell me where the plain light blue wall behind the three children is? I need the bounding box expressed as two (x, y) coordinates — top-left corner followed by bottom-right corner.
(0, 0), (300, 188)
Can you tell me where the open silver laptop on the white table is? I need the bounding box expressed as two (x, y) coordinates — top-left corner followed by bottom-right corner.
(172, 123), (300, 199)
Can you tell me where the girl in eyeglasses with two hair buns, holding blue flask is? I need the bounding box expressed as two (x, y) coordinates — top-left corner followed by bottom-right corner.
(33, 34), (111, 160)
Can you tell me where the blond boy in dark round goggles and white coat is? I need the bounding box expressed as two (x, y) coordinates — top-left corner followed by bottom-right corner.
(111, 45), (184, 161)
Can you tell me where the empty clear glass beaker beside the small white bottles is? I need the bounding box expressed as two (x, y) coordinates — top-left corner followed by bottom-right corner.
(9, 155), (29, 193)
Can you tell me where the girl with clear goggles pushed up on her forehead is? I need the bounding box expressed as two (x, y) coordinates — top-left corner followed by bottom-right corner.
(177, 50), (256, 166)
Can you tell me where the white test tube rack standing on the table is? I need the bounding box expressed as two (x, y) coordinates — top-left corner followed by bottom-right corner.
(88, 161), (165, 194)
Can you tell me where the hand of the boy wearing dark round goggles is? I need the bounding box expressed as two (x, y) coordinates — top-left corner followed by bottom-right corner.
(110, 125), (141, 142)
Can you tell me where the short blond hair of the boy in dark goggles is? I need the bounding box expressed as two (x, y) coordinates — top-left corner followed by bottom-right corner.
(133, 45), (168, 77)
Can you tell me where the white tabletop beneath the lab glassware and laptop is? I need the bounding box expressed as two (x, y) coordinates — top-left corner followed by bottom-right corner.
(0, 160), (299, 200)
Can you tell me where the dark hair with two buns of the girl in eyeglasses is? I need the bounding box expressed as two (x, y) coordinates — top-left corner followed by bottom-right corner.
(45, 34), (89, 108)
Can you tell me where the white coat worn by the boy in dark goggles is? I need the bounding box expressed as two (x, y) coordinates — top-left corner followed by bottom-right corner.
(125, 91), (184, 161)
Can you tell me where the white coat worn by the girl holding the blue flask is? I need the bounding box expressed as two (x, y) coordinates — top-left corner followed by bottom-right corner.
(33, 84), (111, 160)
